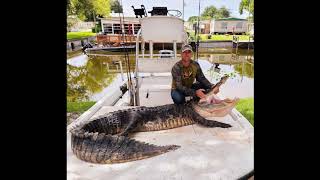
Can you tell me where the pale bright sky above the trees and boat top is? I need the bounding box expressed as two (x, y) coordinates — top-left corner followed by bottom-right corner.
(119, 0), (248, 20)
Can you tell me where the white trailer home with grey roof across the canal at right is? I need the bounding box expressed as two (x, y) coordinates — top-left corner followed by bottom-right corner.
(210, 18), (248, 34)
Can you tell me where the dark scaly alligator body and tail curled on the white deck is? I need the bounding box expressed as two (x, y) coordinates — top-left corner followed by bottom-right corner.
(70, 75), (235, 164)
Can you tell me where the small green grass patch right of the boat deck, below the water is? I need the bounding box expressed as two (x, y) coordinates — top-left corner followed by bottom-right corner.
(236, 98), (254, 125)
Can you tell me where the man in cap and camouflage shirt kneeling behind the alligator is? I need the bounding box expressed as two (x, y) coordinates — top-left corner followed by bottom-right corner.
(171, 44), (219, 104)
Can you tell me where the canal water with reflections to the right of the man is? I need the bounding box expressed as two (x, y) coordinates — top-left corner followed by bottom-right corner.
(198, 52), (254, 98)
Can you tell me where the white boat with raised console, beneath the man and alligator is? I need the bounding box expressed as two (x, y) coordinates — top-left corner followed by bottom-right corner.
(67, 16), (253, 180)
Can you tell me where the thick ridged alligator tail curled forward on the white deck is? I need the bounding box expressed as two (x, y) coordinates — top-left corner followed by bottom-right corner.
(71, 129), (180, 164)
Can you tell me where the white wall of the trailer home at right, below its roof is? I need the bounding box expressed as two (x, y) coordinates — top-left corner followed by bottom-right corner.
(210, 20), (248, 33)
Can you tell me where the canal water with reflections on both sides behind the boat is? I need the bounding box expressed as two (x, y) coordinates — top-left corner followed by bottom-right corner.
(67, 50), (254, 102)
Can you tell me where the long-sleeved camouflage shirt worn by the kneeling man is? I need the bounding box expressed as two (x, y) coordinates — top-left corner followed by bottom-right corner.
(171, 60), (213, 96)
